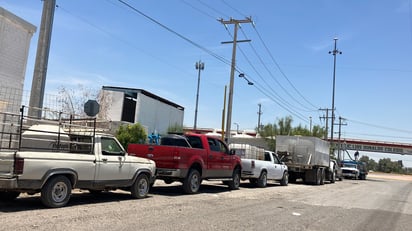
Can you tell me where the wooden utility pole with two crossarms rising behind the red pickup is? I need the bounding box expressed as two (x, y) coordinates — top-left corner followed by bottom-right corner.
(219, 17), (252, 142)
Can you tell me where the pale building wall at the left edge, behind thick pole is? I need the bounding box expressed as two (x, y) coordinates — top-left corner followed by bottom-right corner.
(0, 7), (36, 113)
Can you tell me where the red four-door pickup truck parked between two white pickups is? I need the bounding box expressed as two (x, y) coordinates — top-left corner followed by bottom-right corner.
(128, 133), (241, 194)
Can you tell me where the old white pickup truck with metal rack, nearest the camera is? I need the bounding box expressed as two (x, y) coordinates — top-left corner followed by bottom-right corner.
(0, 108), (156, 207)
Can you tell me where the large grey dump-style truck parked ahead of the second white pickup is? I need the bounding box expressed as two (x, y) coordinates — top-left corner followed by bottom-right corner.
(276, 135), (336, 185)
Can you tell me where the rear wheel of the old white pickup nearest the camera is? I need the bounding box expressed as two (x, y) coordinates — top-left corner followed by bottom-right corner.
(40, 176), (72, 208)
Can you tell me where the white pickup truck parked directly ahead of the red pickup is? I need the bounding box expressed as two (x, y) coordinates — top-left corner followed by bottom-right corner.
(230, 144), (289, 188)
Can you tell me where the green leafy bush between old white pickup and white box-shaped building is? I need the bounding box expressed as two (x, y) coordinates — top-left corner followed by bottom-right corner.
(116, 123), (147, 148)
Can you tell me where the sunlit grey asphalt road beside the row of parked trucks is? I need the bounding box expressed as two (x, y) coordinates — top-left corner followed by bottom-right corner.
(0, 175), (412, 231)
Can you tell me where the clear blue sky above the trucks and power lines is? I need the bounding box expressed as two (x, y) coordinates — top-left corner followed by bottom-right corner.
(0, 0), (412, 165)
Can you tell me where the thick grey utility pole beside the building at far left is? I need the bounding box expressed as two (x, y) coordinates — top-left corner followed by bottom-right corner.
(29, 0), (56, 119)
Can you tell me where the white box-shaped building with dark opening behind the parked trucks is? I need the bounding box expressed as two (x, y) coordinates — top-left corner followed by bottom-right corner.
(99, 86), (184, 134)
